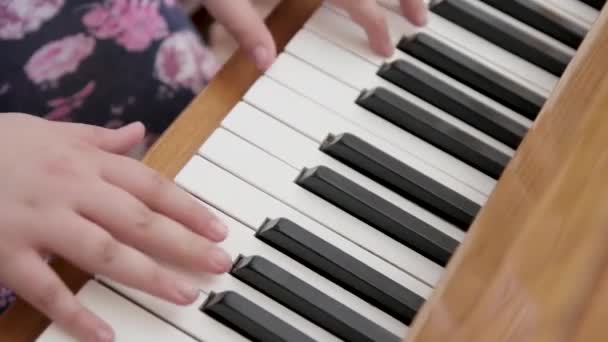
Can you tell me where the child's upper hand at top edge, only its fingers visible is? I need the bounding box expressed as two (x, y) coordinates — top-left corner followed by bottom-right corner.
(203, 0), (427, 70)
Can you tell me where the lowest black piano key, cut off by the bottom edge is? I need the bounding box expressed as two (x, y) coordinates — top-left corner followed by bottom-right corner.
(200, 291), (314, 342)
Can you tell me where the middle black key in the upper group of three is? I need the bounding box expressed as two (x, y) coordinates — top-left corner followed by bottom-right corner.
(378, 60), (527, 149)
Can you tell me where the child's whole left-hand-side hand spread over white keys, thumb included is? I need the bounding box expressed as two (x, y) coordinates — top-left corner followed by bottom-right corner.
(0, 114), (231, 341)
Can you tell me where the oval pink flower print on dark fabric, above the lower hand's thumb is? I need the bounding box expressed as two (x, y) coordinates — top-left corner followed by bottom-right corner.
(25, 33), (95, 84)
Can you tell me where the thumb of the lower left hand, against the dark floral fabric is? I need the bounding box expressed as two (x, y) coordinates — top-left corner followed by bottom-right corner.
(64, 122), (146, 154)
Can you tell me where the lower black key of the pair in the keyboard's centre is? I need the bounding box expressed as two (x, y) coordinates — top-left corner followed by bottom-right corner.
(296, 166), (458, 266)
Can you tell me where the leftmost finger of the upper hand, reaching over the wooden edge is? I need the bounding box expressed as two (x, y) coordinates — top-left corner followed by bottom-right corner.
(205, 0), (276, 70)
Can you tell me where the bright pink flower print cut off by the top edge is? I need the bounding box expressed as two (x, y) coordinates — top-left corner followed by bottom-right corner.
(82, 0), (169, 51)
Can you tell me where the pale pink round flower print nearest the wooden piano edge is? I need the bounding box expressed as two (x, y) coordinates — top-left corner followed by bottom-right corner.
(155, 31), (218, 94)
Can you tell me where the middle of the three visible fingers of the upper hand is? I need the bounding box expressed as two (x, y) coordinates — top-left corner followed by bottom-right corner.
(332, 0), (394, 57)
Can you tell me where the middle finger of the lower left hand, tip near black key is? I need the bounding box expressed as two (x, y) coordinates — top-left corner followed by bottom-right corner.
(77, 182), (232, 273)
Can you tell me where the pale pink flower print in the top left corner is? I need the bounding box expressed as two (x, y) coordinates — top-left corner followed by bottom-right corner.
(0, 0), (64, 40)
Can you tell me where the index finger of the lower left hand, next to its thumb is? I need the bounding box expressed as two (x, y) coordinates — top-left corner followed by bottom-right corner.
(99, 153), (227, 241)
